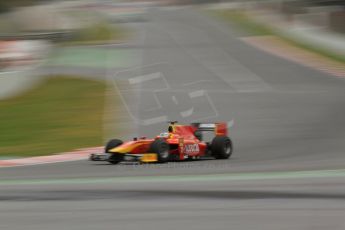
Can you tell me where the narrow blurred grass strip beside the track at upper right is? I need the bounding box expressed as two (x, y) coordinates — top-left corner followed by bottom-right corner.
(211, 10), (345, 63)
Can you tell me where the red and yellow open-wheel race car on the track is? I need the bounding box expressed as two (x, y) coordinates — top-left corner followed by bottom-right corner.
(89, 121), (233, 164)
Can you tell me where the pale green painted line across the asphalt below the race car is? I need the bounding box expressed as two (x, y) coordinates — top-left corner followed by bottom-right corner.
(0, 169), (345, 186)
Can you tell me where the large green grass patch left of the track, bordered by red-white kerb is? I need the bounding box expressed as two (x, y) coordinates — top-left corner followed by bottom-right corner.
(0, 76), (106, 156)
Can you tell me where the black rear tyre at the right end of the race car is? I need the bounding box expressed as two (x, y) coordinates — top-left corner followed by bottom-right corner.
(211, 136), (233, 159)
